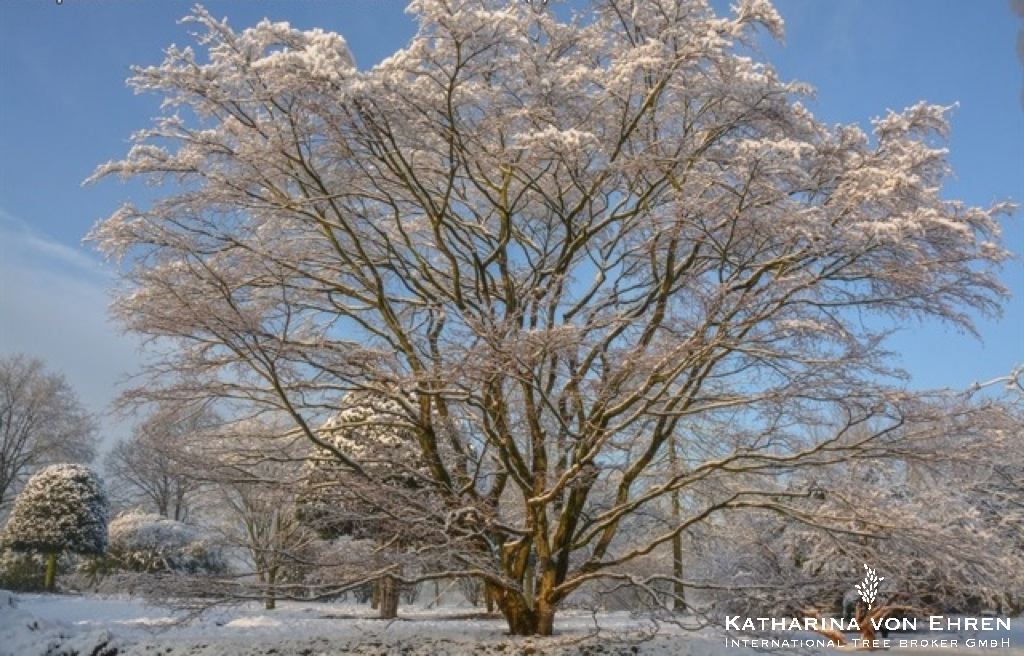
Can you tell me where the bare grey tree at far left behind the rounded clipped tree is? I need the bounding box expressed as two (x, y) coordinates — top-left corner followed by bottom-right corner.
(0, 355), (96, 510)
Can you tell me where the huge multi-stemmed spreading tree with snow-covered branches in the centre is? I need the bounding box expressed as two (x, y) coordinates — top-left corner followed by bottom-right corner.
(92, 0), (1008, 633)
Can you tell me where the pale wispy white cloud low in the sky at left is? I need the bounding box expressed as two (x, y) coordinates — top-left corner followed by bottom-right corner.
(0, 210), (139, 448)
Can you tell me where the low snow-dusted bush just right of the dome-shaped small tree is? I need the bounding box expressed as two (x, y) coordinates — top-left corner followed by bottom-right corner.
(96, 511), (227, 574)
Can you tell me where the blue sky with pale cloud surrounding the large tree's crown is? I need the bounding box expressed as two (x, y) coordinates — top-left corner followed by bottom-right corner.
(0, 0), (1024, 440)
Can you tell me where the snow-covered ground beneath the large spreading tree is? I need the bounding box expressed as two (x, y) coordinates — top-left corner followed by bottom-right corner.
(0, 592), (1024, 656)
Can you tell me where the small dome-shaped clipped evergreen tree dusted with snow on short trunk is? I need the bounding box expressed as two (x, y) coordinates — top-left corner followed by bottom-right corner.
(4, 465), (108, 591)
